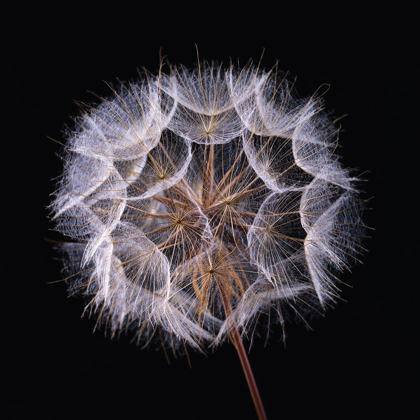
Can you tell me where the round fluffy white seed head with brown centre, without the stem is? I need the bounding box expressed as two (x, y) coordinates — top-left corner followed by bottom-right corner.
(52, 60), (363, 349)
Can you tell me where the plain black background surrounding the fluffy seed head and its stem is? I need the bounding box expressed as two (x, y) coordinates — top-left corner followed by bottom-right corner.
(1, 4), (420, 419)
